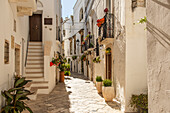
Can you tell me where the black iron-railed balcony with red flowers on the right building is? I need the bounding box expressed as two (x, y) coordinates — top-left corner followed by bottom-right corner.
(99, 13), (114, 44)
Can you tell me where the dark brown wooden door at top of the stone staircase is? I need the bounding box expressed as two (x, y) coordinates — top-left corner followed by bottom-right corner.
(29, 14), (42, 42)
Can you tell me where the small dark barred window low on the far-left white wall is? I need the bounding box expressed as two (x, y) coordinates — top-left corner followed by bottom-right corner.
(4, 40), (9, 64)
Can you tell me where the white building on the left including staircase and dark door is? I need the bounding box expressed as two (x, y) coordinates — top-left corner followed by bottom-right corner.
(0, 0), (61, 107)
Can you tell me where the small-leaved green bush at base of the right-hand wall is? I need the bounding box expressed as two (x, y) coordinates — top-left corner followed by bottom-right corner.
(130, 94), (148, 113)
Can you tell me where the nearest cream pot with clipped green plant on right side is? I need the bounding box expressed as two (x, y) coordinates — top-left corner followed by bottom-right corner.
(102, 79), (115, 101)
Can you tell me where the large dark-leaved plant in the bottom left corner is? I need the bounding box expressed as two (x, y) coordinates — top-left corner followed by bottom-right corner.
(1, 76), (33, 113)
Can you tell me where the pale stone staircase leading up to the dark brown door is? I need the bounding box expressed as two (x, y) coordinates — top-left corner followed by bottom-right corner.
(25, 42), (49, 100)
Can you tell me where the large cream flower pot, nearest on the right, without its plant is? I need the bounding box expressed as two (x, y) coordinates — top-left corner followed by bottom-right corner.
(102, 86), (115, 102)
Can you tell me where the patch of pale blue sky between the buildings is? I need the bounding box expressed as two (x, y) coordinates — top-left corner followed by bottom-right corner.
(61, 0), (77, 19)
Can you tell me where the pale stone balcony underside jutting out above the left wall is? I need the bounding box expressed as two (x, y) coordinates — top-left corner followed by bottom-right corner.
(9, 0), (37, 16)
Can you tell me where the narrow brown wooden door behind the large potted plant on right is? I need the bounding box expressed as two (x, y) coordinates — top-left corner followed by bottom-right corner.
(106, 54), (112, 80)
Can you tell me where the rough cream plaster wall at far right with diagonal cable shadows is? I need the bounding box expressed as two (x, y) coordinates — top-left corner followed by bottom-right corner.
(147, 0), (170, 113)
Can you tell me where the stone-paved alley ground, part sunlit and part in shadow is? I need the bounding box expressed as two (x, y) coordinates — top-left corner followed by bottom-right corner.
(24, 73), (121, 113)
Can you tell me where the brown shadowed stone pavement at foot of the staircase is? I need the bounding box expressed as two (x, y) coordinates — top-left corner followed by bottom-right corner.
(24, 83), (72, 113)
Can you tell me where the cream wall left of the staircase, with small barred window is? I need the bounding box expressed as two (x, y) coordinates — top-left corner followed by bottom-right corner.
(0, 0), (29, 108)
